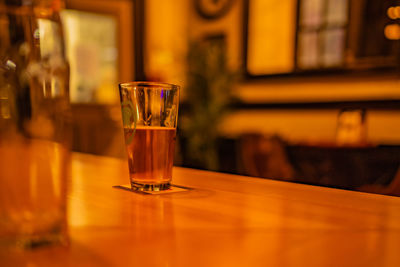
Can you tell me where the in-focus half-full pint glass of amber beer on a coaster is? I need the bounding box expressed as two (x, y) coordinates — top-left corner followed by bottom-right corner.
(119, 82), (179, 191)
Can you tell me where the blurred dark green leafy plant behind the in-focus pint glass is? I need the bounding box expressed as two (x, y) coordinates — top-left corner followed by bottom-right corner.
(179, 38), (237, 170)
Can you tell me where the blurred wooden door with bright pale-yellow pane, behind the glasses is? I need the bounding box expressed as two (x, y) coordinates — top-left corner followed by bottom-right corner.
(61, 0), (144, 157)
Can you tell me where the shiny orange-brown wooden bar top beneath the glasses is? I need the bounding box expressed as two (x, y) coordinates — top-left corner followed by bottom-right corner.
(0, 153), (400, 266)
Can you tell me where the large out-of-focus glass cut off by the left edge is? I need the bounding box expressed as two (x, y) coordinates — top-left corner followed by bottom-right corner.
(0, 0), (71, 247)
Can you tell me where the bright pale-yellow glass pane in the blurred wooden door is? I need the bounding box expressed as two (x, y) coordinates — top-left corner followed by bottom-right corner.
(62, 10), (118, 103)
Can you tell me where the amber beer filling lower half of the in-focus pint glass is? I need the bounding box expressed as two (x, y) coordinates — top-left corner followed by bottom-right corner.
(124, 126), (176, 189)
